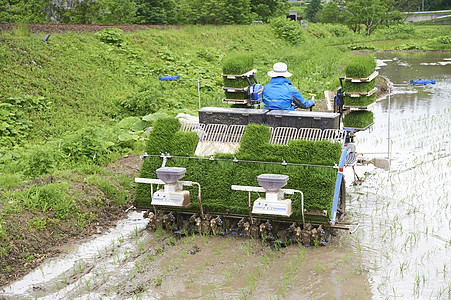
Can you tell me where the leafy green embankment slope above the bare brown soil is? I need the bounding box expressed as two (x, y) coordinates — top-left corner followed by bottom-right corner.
(0, 24), (451, 176)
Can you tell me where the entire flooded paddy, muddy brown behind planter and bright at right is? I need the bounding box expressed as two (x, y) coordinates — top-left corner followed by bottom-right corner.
(0, 53), (451, 299)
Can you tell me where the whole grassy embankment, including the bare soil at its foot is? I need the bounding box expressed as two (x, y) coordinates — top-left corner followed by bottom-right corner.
(0, 24), (451, 285)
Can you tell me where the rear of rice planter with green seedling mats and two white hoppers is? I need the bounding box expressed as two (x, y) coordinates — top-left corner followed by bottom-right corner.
(135, 71), (388, 244)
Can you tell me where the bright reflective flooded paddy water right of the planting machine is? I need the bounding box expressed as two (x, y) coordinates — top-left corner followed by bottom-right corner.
(348, 53), (451, 299)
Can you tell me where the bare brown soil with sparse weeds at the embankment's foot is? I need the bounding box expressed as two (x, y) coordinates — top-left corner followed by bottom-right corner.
(0, 156), (141, 286)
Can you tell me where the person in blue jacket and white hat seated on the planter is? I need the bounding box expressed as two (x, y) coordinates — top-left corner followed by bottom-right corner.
(263, 62), (315, 110)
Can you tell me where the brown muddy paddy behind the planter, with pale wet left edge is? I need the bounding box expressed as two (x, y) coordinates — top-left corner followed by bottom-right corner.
(0, 212), (371, 299)
